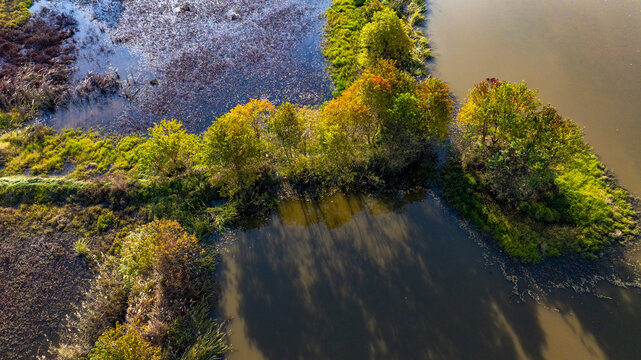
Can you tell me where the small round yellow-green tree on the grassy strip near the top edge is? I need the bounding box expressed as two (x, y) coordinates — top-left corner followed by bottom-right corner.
(360, 7), (414, 67)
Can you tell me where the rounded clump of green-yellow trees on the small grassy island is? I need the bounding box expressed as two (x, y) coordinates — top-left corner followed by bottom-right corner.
(458, 79), (585, 203)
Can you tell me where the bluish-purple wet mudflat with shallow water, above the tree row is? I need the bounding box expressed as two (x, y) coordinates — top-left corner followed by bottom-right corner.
(31, 0), (332, 133)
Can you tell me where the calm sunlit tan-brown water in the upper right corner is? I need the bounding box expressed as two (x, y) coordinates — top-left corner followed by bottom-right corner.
(429, 0), (641, 195)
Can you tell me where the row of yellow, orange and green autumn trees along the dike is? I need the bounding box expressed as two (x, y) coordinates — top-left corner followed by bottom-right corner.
(137, 60), (452, 194)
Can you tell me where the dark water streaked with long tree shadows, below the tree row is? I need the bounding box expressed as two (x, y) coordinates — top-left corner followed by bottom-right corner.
(220, 194), (641, 359)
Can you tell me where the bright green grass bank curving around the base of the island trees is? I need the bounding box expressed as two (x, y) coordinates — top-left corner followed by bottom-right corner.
(441, 152), (639, 262)
